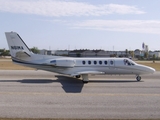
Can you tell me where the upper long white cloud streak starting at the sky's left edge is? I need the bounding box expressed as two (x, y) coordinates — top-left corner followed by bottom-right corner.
(0, 0), (145, 17)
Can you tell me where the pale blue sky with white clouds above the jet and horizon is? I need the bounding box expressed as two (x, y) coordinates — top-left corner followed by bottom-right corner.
(0, 0), (160, 51)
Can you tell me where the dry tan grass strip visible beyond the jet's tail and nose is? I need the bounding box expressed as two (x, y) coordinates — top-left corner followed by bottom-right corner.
(0, 59), (160, 71)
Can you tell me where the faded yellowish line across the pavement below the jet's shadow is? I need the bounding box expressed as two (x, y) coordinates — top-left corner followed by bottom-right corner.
(0, 92), (160, 96)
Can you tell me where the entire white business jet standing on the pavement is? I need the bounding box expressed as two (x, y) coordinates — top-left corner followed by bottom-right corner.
(5, 32), (155, 83)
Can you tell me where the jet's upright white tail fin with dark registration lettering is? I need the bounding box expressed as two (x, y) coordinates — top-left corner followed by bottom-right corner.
(5, 32), (32, 58)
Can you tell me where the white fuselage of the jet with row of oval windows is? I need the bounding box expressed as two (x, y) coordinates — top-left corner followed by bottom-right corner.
(13, 54), (155, 75)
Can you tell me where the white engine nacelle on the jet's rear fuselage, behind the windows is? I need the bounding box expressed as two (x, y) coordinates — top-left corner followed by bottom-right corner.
(50, 59), (75, 67)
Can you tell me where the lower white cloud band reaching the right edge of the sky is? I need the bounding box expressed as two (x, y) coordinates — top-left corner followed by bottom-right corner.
(73, 20), (160, 34)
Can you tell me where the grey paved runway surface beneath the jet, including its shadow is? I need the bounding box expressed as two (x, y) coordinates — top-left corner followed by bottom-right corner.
(0, 70), (160, 119)
